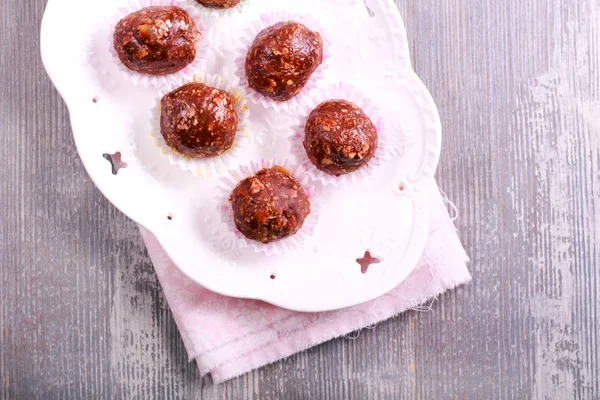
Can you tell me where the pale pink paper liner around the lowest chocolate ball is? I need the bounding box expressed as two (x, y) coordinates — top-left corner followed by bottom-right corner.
(217, 159), (318, 256)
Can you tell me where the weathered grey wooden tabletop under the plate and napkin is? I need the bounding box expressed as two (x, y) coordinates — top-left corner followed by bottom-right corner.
(0, 0), (600, 400)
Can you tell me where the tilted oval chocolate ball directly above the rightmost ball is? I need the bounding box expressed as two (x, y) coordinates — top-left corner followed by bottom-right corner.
(246, 22), (323, 101)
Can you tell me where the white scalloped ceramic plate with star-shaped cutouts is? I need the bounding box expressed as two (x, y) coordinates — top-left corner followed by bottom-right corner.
(41, 0), (441, 311)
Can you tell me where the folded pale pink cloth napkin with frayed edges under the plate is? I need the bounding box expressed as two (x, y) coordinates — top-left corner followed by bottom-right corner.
(141, 188), (471, 383)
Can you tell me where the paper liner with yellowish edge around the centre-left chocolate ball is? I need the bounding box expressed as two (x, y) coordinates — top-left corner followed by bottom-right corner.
(148, 74), (251, 177)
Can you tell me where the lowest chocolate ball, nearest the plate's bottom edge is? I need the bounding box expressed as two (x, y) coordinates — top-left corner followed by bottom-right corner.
(229, 166), (310, 244)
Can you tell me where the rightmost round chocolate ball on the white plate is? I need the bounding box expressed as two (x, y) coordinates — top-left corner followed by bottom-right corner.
(304, 100), (378, 176)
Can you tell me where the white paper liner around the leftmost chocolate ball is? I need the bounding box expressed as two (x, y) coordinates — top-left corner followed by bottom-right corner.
(108, 0), (210, 88)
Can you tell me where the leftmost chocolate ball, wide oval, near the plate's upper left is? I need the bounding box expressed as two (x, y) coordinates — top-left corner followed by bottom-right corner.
(113, 6), (200, 75)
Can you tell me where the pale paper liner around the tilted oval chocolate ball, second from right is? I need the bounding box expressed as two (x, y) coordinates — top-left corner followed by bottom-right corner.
(235, 11), (330, 112)
